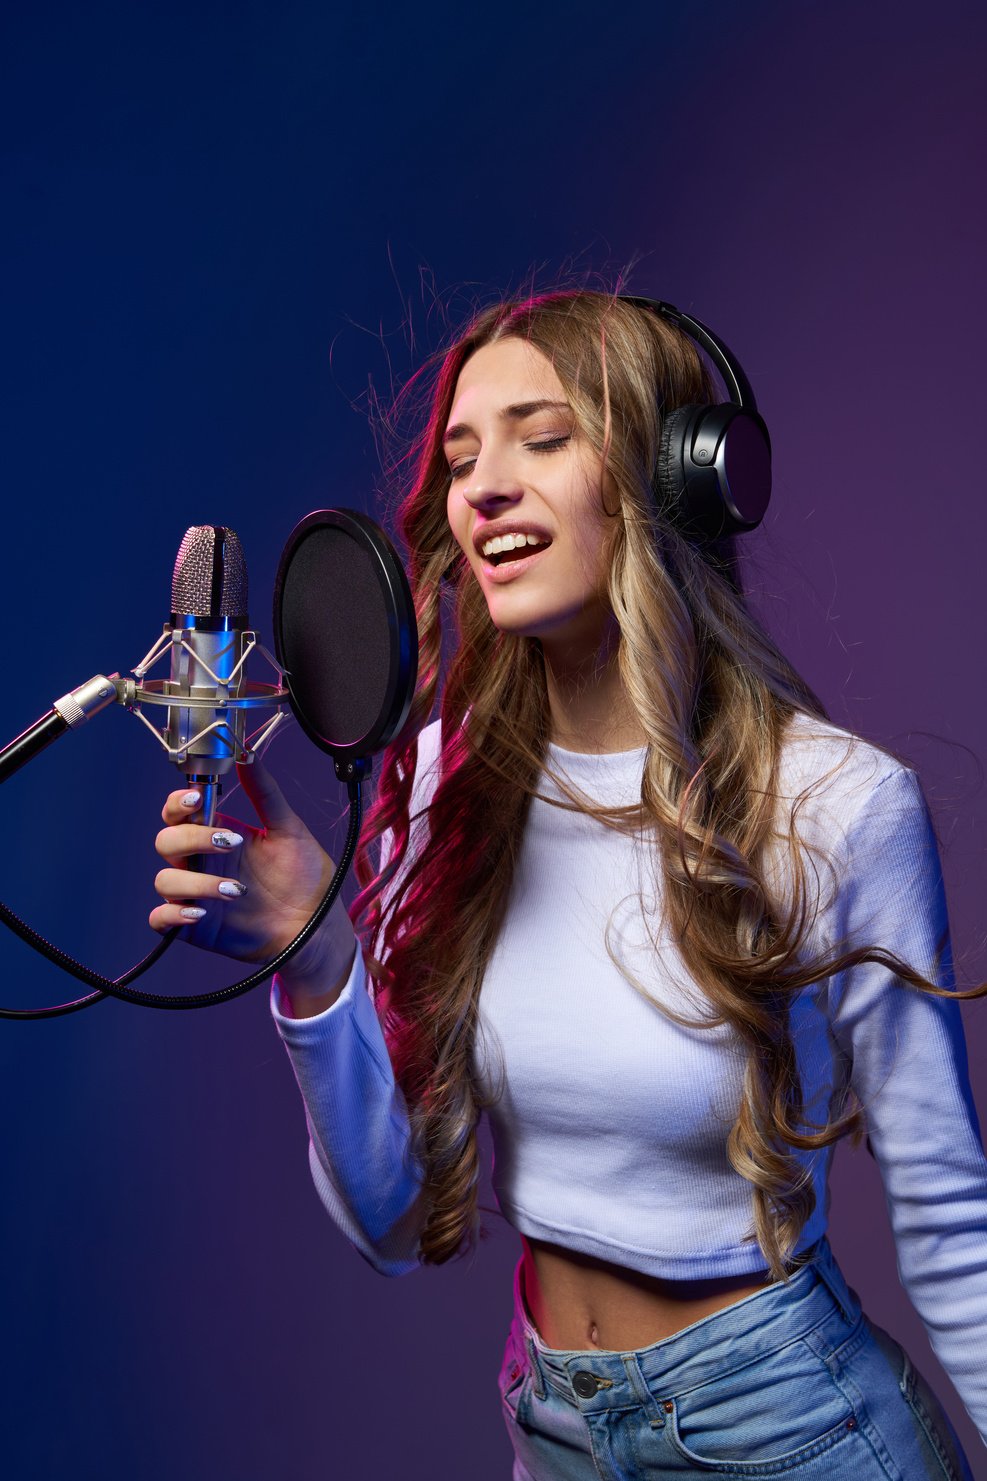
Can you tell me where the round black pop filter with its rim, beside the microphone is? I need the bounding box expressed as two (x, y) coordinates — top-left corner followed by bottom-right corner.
(274, 509), (418, 779)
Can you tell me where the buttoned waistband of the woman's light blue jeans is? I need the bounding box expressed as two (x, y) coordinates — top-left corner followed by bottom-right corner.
(514, 1237), (861, 1408)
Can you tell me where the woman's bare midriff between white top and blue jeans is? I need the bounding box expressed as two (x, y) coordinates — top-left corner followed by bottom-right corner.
(522, 1237), (769, 1352)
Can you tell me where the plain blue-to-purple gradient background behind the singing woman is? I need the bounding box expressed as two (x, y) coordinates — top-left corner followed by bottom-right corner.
(0, 0), (987, 1481)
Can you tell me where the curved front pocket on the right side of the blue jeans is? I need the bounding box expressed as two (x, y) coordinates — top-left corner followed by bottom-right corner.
(657, 1339), (857, 1478)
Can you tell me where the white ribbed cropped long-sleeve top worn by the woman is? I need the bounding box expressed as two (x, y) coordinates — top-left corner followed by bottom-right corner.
(271, 715), (987, 1441)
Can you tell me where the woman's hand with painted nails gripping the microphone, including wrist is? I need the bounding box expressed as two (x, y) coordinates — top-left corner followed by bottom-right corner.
(150, 761), (356, 1017)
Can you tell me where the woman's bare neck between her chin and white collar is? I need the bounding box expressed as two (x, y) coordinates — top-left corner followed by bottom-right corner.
(542, 621), (648, 754)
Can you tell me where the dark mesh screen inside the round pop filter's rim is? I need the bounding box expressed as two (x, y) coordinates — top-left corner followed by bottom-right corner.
(280, 526), (393, 746)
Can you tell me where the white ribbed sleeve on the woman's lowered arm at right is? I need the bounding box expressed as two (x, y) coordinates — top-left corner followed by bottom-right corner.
(830, 767), (987, 1442)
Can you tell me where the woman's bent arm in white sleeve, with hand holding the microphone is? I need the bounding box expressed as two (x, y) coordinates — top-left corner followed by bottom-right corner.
(151, 728), (435, 1275)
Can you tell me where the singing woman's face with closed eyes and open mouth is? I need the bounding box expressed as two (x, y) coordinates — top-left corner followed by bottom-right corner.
(445, 339), (614, 656)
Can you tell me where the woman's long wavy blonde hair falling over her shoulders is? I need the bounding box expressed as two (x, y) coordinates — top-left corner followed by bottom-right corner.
(351, 290), (987, 1280)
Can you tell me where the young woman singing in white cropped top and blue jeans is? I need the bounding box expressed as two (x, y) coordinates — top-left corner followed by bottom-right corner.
(151, 292), (987, 1481)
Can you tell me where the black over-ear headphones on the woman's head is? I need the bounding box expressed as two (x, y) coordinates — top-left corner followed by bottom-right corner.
(621, 293), (771, 541)
